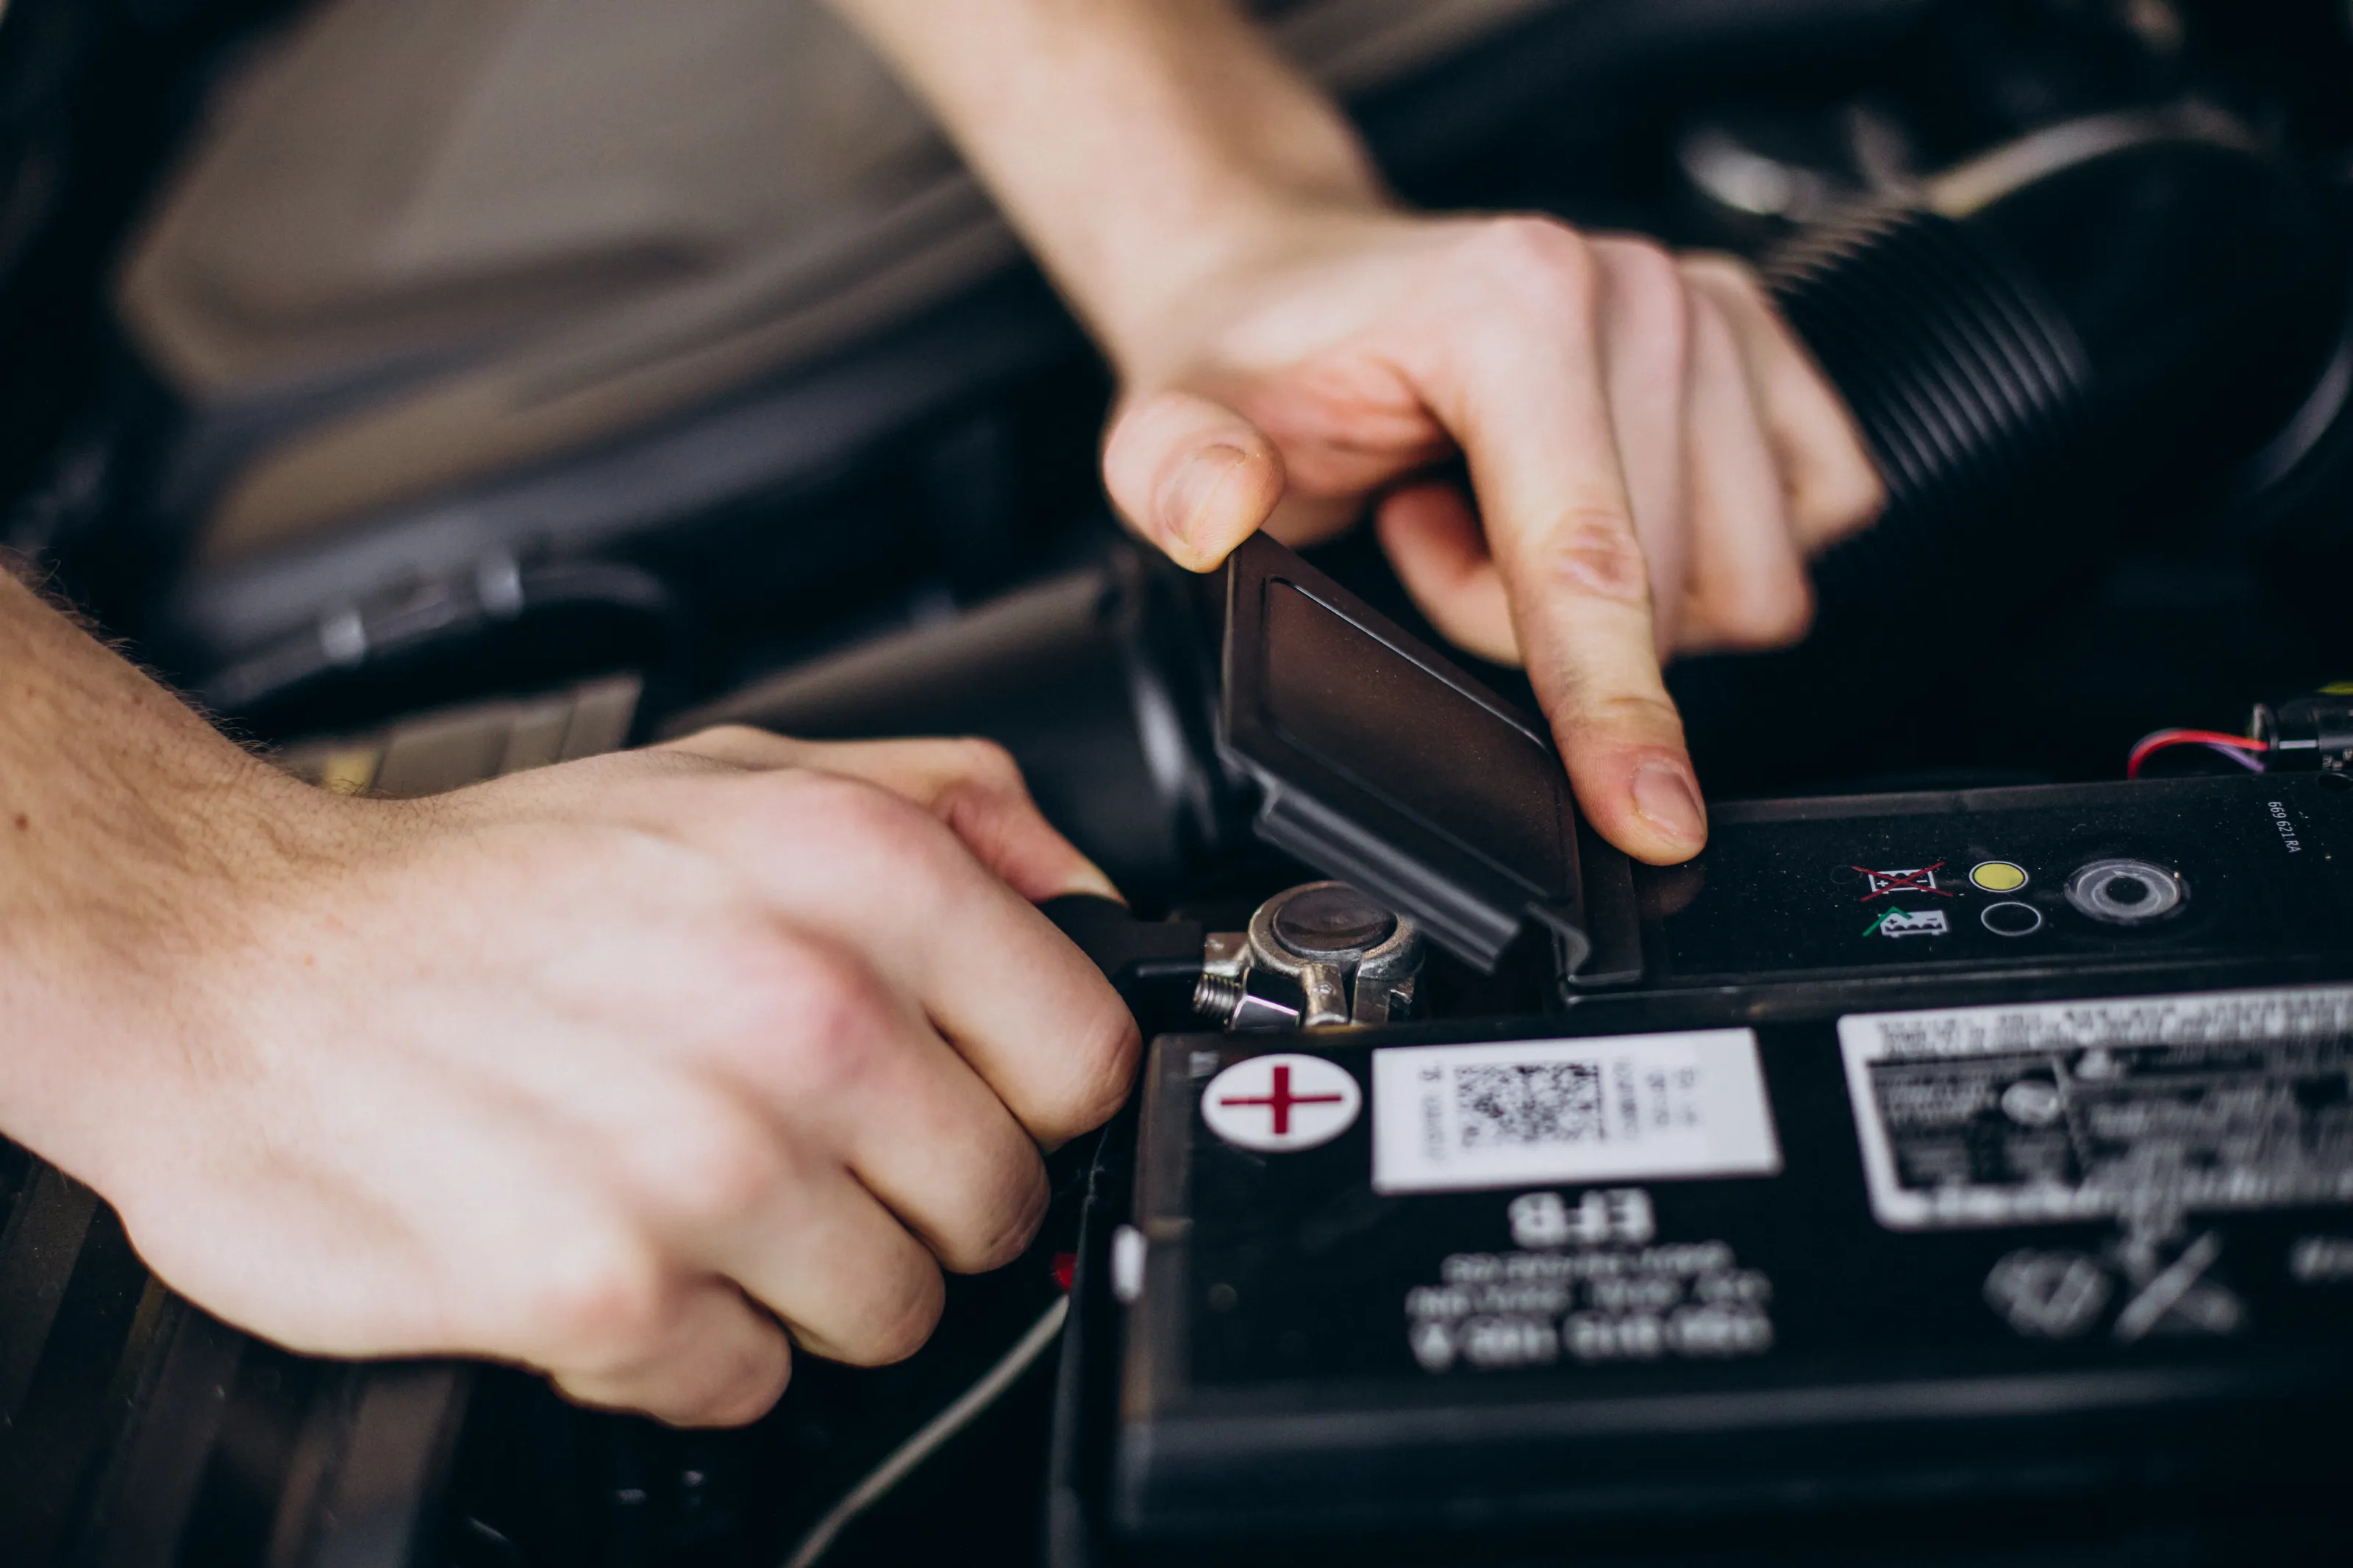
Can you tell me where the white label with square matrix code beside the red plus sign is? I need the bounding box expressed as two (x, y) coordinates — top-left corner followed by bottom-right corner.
(1372, 1030), (1781, 1192)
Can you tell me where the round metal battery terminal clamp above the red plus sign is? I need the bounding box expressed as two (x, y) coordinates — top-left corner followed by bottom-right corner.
(1193, 881), (1421, 1030)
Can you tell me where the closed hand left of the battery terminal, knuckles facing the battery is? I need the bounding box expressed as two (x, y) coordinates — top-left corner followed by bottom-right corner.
(40, 731), (1137, 1422)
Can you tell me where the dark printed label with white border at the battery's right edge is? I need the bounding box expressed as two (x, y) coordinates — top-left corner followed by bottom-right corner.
(1838, 985), (2353, 1230)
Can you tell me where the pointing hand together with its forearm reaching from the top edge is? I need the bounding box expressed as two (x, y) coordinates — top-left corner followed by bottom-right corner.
(833, 0), (1882, 865)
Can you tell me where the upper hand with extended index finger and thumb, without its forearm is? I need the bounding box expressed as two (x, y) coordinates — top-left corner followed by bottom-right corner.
(1101, 215), (1882, 863)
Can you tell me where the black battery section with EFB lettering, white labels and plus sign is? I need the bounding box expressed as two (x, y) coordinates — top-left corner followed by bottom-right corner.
(1108, 985), (2353, 1537)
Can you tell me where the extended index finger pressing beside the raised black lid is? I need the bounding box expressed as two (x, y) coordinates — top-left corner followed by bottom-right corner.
(1400, 218), (1706, 865)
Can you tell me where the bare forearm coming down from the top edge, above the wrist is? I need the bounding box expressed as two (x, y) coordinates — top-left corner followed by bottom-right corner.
(833, 0), (1381, 367)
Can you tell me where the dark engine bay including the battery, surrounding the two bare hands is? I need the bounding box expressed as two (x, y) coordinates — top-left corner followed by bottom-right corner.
(0, 0), (2353, 1568)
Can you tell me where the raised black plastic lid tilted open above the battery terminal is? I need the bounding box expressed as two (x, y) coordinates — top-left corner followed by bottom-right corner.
(1219, 536), (1590, 971)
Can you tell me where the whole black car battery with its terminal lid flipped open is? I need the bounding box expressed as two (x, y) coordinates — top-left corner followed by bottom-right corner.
(1051, 545), (2353, 1564)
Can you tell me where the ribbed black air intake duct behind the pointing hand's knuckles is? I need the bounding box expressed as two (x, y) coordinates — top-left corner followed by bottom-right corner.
(1767, 110), (2346, 620)
